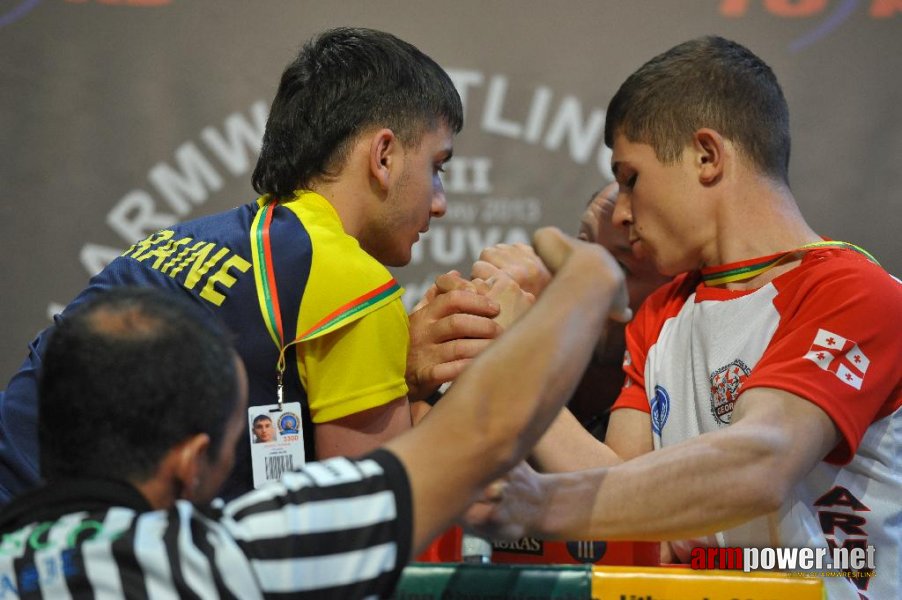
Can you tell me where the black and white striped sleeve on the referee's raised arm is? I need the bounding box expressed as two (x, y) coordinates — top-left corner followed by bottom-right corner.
(222, 450), (413, 598)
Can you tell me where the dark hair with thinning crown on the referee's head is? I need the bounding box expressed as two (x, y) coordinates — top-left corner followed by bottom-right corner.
(38, 287), (238, 481)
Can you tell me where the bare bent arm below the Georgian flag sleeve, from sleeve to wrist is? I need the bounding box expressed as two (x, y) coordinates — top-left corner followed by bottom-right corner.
(535, 389), (839, 540)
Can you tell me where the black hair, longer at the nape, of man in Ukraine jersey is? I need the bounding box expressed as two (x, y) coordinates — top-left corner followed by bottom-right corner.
(252, 28), (463, 197)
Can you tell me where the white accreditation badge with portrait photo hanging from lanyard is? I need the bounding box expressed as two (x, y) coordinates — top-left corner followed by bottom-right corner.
(247, 402), (306, 488)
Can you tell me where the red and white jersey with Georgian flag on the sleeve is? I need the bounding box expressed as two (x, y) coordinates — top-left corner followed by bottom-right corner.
(614, 248), (902, 599)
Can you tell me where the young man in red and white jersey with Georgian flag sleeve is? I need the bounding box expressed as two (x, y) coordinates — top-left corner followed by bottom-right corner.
(470, 37), (902, 599)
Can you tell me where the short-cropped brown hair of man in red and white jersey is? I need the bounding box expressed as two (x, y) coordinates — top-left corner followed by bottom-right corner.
(604, 36), (790, 183)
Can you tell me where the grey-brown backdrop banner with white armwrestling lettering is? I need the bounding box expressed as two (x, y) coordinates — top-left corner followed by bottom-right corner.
(0, 0), (902, 388)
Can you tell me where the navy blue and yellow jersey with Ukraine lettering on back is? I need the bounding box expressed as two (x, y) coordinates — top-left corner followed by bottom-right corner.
(0, 192), (409, 502)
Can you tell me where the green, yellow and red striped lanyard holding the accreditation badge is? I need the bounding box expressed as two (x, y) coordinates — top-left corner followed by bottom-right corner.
(251, 200), (400, 407)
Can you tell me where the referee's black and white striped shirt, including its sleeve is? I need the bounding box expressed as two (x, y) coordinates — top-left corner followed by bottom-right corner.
(0, 450), (412, 600)
